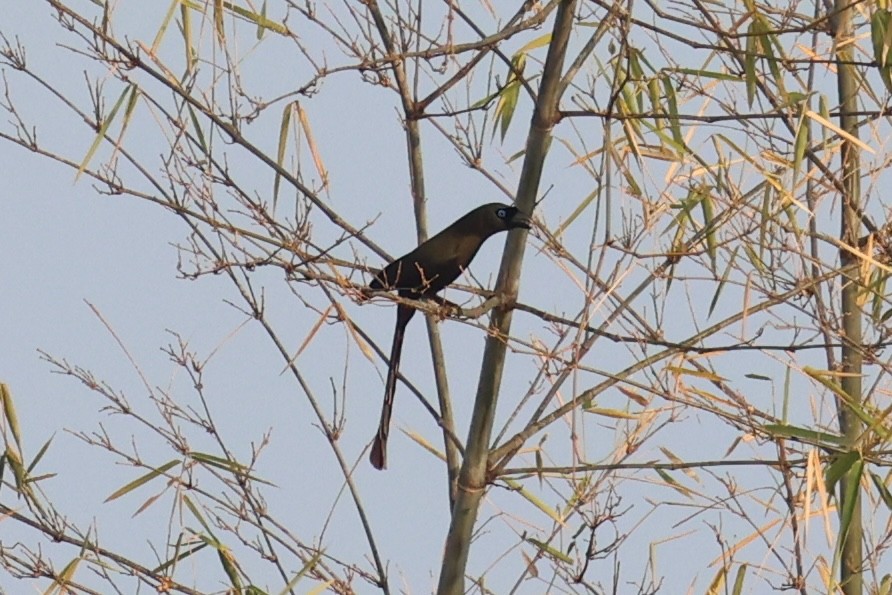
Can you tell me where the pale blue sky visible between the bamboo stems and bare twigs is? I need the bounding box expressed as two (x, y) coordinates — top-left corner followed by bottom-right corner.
(0, 1), (880, 593)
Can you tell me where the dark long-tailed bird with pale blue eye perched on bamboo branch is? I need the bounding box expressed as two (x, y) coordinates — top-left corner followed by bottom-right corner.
(369, 203), (532, 469)
